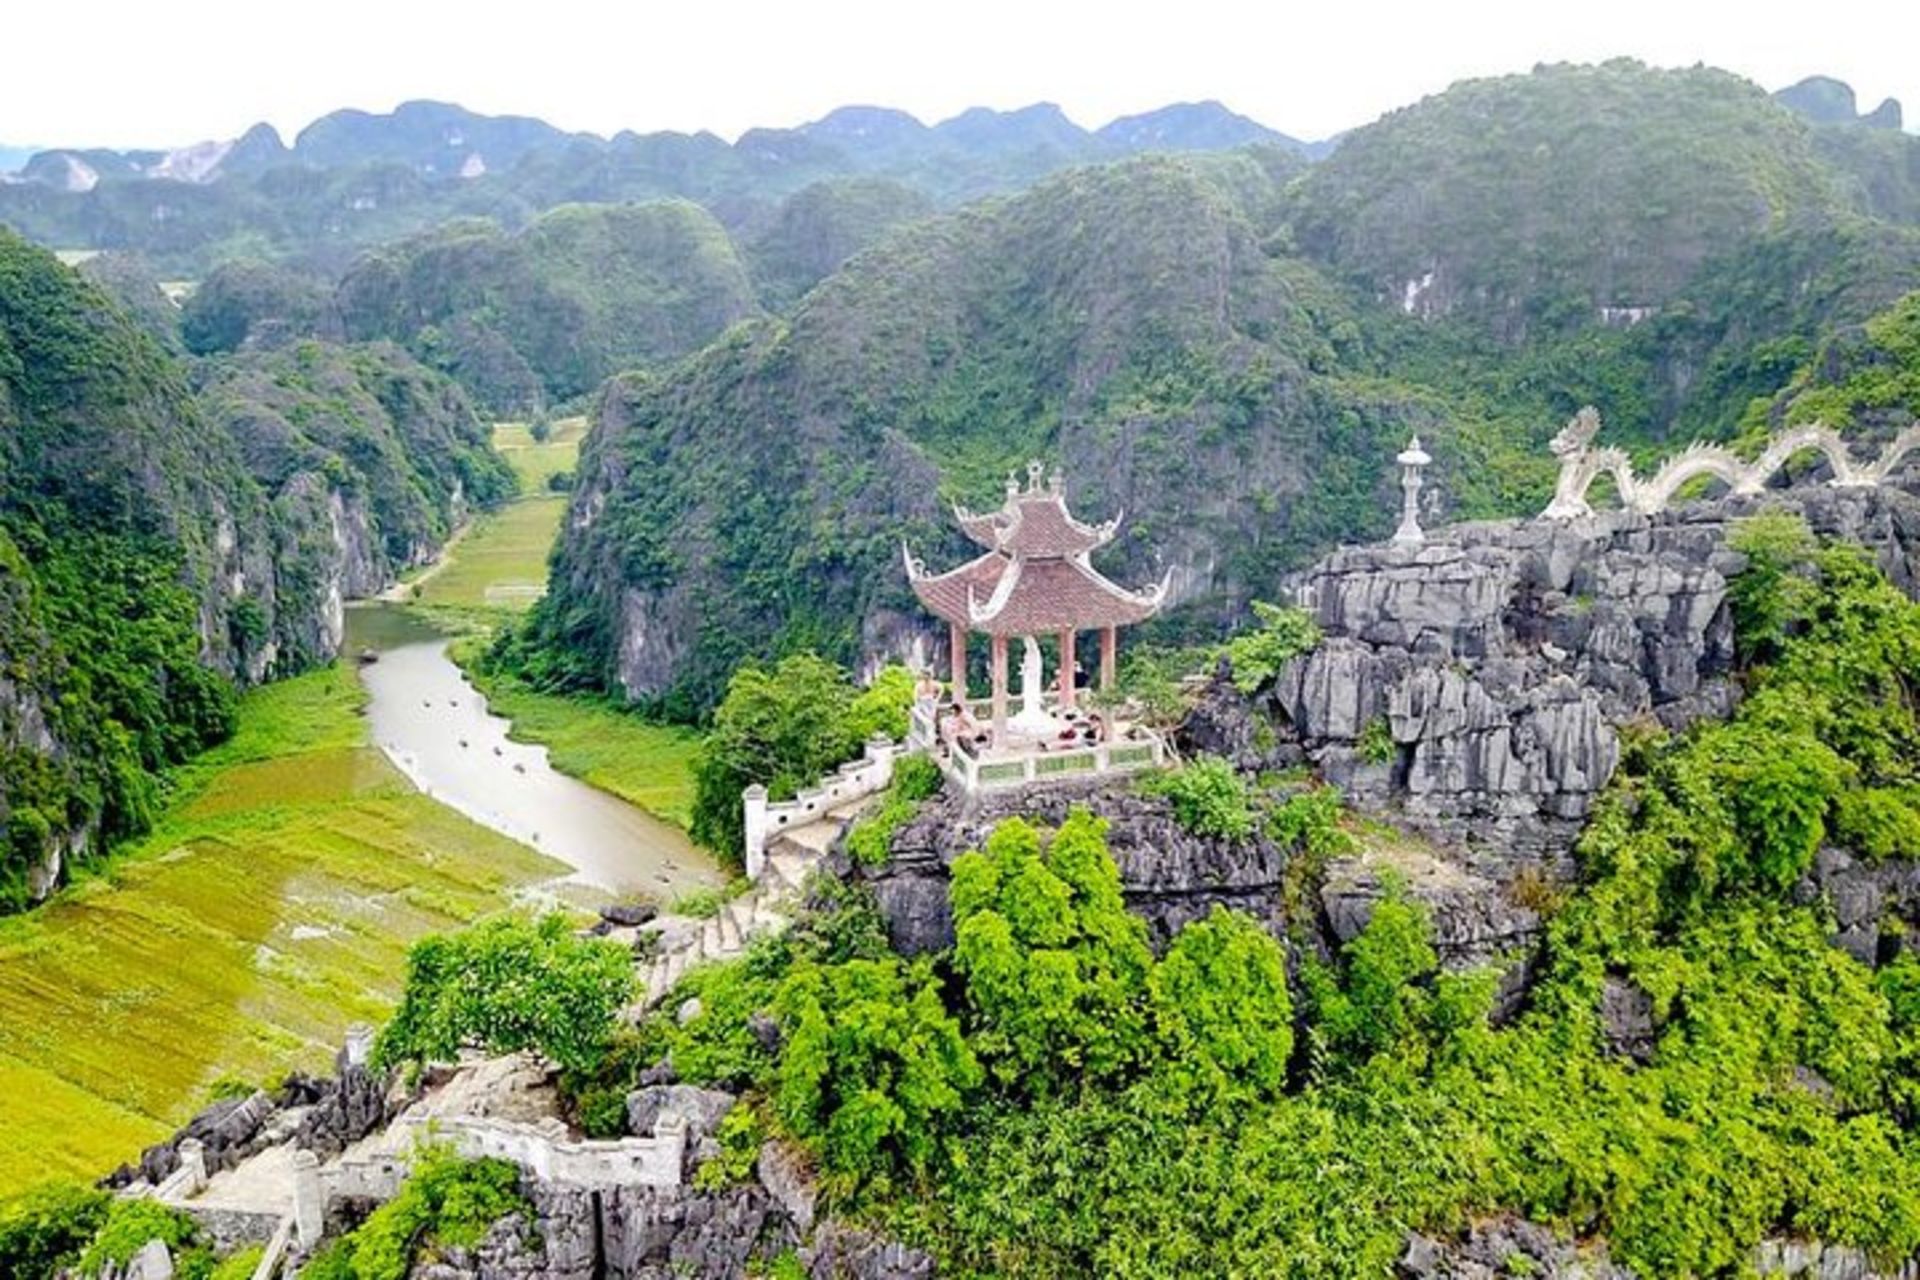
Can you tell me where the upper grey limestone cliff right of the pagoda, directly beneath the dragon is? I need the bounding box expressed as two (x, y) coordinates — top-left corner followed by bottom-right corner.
(1244, 487), (1920, 881)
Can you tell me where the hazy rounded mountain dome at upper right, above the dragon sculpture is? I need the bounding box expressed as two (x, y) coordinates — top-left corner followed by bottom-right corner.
(1294, 61), (1841, 340)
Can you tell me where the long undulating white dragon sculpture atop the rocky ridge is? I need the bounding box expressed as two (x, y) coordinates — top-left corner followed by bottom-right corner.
(1540, 405), (1920, 520)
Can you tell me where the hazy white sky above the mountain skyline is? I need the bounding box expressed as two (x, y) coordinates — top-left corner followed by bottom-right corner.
(0, 0), (1920, 146)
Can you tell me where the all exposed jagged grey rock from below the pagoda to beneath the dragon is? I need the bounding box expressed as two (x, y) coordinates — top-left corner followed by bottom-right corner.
(864, 487), (1920, 997)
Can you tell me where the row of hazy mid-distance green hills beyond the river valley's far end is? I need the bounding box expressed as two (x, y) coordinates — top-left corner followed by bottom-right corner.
(179, 178), (933, 413)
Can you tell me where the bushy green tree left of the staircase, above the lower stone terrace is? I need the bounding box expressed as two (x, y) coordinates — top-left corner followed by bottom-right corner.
(374, 913), (634, 1071)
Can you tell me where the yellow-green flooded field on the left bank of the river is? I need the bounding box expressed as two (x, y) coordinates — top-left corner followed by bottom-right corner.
(0, 666), (563, 1201)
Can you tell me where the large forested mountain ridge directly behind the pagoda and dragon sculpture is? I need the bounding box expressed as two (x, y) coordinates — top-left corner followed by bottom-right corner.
(518, 61), (1920, 710)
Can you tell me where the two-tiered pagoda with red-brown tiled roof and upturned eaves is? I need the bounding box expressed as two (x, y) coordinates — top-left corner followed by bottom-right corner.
(900, 462), (1171, 748)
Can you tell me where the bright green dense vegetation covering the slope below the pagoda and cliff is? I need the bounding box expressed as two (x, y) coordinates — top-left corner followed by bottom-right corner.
(389, 516), (1920, 1276)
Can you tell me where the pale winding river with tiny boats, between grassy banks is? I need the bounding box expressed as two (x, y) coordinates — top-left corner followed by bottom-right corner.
(346, 604), (720, 898)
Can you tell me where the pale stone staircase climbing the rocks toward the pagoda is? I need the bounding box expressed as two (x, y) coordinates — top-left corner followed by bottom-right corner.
(628, 817), (864, 1019)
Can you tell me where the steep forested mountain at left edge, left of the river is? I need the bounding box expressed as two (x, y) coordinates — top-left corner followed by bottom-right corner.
(0, 232), (509, 910)
